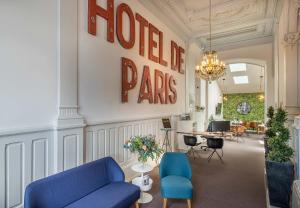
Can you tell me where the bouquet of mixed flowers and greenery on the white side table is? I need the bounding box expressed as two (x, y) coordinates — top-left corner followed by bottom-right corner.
(124, 135), (163, 164)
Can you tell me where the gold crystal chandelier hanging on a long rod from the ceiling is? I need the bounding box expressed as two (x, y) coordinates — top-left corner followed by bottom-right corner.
(195, 0), (226, 82)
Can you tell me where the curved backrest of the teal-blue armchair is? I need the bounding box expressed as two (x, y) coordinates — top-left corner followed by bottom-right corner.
(159, 152), (192, 180)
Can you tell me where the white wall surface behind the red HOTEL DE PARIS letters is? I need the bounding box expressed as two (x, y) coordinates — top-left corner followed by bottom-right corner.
(78, 0), (185, 123)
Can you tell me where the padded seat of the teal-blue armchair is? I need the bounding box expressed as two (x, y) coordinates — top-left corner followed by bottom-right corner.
(160, 175), (193, 199)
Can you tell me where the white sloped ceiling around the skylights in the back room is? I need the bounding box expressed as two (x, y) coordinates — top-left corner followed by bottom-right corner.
(217, 64), (264, 94)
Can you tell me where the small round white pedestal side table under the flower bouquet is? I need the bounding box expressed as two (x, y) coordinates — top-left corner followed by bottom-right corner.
(131, 163), (153, 204)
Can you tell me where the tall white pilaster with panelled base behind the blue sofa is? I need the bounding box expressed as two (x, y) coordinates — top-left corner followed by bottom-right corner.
(54, 0), (85, 172)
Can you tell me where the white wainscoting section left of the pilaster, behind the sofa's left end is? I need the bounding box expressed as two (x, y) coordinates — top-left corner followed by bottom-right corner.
(0, 131), (53, 208)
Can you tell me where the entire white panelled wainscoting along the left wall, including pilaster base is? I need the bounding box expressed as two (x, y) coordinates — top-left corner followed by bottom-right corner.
(0, 115), (170, 208)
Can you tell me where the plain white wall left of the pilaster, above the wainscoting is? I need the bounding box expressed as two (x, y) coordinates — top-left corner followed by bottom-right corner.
(0, 0), (58, 132)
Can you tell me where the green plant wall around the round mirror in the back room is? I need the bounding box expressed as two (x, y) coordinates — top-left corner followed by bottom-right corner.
(223, 93), (265, 121)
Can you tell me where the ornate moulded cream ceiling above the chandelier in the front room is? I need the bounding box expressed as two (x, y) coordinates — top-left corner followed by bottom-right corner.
(139, 0), (282, 50)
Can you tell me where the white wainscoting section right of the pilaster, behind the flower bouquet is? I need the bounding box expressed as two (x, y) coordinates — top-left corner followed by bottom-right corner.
(85, 118), (163, 169)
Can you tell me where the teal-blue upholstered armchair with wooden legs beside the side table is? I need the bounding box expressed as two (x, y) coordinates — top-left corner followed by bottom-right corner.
(159, 152), (193, 208)
